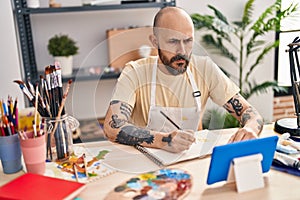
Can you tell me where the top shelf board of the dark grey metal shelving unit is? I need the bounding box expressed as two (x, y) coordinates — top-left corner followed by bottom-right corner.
(17, 2), (172, 15)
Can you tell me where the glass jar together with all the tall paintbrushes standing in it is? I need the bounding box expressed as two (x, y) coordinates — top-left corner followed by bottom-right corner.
(14, 62), (79, 161)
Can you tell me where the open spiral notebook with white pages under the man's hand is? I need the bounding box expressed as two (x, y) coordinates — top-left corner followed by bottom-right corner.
(103, 129), (237, 174)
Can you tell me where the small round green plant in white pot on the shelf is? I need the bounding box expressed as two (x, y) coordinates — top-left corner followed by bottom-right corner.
(47, 34), (78, 76)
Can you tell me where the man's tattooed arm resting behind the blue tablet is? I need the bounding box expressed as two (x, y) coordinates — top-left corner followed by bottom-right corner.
(224, 94), (263, 142)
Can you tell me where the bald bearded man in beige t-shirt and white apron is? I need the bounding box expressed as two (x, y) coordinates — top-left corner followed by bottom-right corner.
(104, 7), (263, 152)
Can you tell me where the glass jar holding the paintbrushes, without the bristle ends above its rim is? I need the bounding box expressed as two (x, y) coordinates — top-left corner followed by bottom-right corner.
(42, 115), (79, 161)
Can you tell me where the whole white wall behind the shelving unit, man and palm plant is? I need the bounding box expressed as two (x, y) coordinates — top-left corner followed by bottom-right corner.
(0, 0), (275, 121)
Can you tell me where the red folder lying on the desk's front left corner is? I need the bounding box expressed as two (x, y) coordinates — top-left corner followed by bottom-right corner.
(0, 173), (86, 200)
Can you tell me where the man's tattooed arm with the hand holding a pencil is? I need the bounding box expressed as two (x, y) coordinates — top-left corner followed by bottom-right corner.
(104, 101), (194, 152)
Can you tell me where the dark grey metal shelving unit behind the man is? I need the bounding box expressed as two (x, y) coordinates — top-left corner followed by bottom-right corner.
(13, 0), (176, 81)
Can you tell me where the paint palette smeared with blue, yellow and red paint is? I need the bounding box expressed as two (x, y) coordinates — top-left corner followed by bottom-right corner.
(106, 168), (192, 200)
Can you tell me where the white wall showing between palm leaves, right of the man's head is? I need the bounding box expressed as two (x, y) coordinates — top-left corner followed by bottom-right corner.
(177, 0), (275, 122)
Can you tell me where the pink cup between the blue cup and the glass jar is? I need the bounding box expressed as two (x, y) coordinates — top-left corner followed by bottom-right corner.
(20, 131), (46, 174)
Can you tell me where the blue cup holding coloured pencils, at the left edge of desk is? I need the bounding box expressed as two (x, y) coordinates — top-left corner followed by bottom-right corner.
(0, 134), (23, 174)
